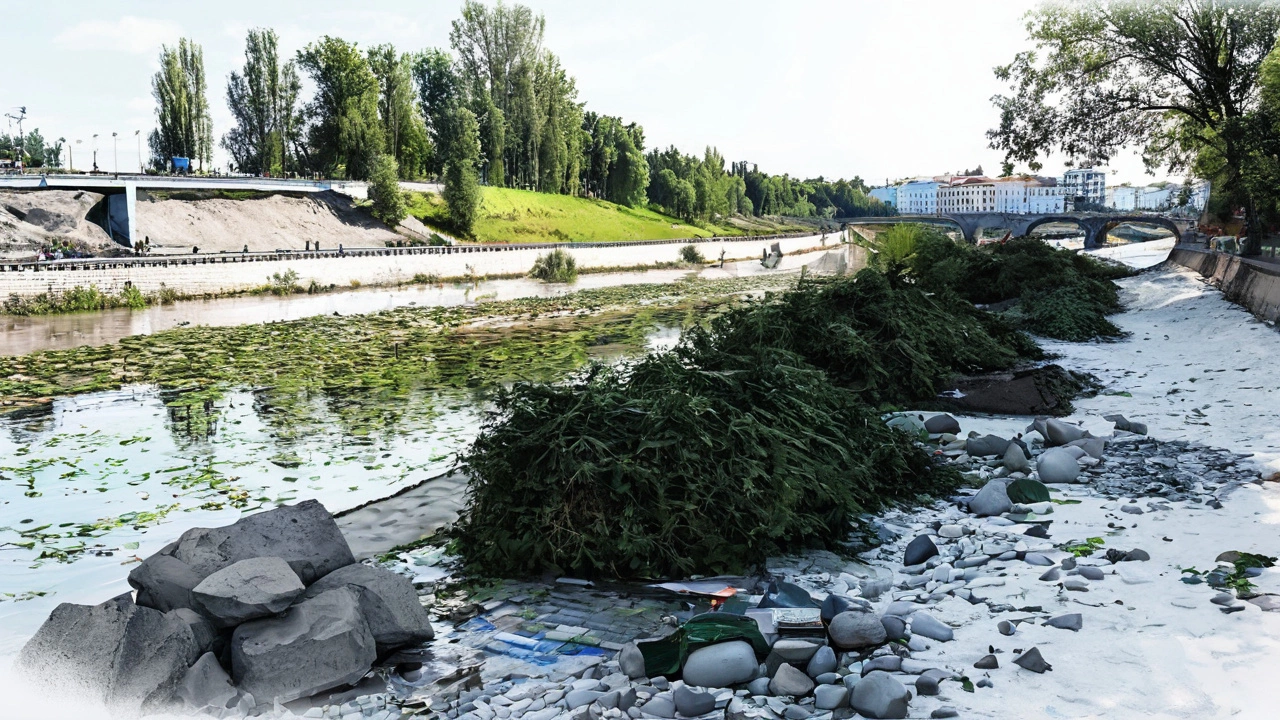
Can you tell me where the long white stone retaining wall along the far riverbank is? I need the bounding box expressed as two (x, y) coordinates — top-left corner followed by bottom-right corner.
(0, 234), (840, 297)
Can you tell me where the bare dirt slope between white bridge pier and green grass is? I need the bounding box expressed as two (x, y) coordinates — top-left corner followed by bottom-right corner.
(137, 191), (403, 254)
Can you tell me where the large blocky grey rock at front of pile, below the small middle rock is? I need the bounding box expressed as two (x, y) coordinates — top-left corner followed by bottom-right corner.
(232, 587), (378, 703)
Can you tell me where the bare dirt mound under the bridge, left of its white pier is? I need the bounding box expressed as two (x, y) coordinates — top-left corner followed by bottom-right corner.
(0, 190), (122, 260)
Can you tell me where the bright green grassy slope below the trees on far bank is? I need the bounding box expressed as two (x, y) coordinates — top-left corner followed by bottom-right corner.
(408, 187), (814, 242)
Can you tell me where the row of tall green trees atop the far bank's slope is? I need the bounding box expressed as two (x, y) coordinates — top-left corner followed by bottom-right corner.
(150, 0), (884, 232)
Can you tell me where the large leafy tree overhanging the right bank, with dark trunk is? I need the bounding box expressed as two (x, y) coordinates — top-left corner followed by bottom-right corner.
(988, 0), (1280, 252)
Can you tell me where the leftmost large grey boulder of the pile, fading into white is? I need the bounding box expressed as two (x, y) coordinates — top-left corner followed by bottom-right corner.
(14, 594), (200, 715)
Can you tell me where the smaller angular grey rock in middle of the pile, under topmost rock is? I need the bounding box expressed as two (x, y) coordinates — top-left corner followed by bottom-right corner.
(191, 557), (307, 628)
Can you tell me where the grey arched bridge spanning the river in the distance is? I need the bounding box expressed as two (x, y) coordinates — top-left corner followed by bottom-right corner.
(836, 213), (1192, 247)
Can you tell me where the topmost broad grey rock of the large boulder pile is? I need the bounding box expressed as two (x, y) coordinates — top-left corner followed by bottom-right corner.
(161, 500), (356, 585)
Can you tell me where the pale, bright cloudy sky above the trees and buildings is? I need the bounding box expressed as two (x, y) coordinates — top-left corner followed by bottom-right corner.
(0, 0), (1152, 184)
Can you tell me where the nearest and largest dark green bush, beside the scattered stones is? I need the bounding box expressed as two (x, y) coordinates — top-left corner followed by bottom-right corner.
(454, 342), (957, 578)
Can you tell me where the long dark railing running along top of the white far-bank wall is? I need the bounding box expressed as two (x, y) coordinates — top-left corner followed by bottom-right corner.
(0, 233), (818, 273)
